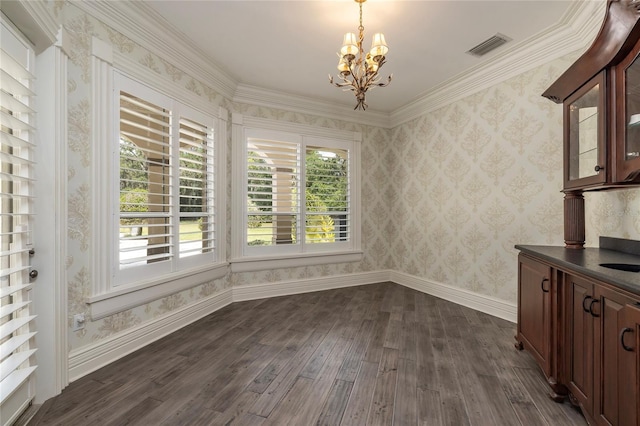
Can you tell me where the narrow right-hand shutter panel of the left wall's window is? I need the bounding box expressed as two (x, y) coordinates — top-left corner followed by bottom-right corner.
(179, 118), (215, 258)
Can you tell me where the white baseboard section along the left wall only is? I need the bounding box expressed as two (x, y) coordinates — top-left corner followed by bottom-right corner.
(69, 289), (233, 382)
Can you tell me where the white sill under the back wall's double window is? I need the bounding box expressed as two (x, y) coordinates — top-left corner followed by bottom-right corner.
(231, 250), (364, 272)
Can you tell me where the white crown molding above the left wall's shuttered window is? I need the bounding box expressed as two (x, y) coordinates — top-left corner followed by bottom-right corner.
(71, 0), (237, 99)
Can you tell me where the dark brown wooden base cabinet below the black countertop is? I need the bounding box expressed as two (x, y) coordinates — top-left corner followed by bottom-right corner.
(516, 260), (640, 426)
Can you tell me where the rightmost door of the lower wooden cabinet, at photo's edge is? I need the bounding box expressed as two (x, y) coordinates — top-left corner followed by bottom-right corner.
(592, 286), (636, 426)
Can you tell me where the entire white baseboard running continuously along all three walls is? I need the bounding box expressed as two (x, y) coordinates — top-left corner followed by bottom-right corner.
(69, 270), (517, 381)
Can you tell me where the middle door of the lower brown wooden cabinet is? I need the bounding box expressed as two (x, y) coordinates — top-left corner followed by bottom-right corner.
(565, 275), (595, 413)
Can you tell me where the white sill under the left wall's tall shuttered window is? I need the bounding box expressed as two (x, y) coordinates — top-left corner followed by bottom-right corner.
(87, 262), (229, 320)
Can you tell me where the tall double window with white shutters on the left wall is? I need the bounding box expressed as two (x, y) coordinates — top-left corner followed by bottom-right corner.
(113, 74), (216, 285)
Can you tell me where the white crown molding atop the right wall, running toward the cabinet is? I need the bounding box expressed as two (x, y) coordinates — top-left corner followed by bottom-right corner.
(390, 0), (606, 127)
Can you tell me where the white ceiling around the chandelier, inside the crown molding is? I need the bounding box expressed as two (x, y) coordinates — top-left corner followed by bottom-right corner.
(144, 0), (572, 113)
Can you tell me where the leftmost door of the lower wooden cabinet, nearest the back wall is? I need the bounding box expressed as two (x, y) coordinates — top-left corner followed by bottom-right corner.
(518, 255), (553, 377)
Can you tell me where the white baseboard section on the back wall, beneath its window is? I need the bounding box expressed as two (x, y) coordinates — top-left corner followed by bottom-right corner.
(233, 271), (389, 302)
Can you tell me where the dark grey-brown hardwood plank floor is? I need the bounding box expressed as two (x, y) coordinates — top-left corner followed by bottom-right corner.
(29, 283), (586, 426)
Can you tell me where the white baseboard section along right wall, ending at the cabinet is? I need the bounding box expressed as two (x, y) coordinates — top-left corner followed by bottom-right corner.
(389, 271), (518, 323)
